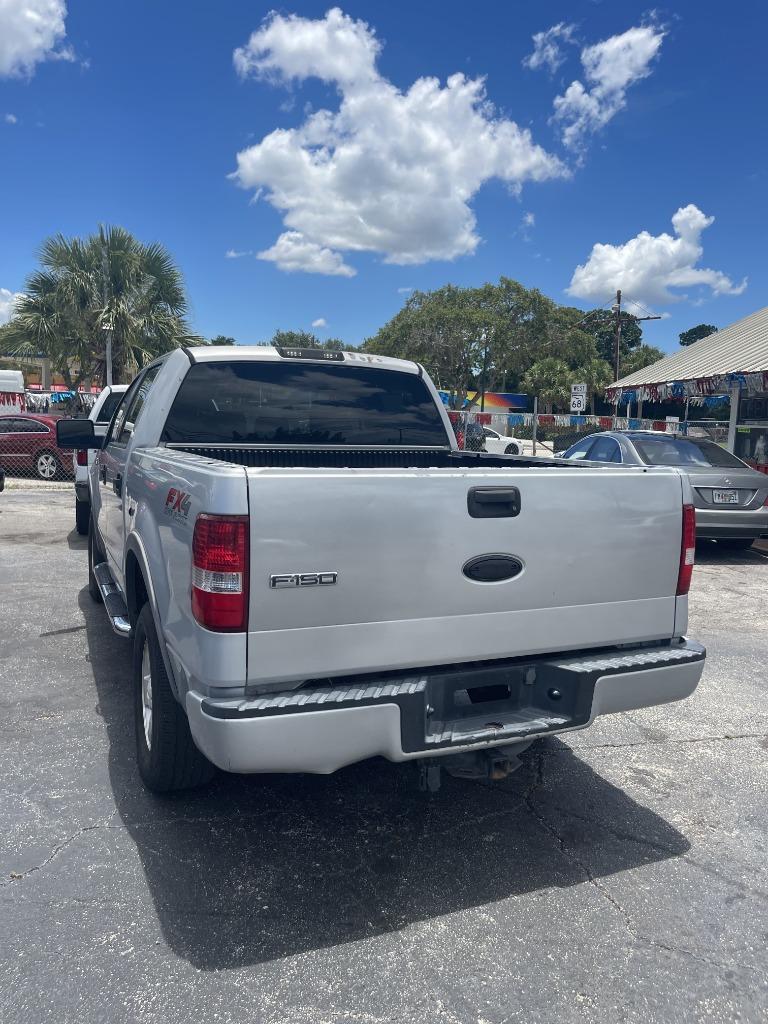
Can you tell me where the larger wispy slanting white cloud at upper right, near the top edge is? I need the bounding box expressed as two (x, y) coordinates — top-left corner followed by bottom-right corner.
(553, 24), (667, 150)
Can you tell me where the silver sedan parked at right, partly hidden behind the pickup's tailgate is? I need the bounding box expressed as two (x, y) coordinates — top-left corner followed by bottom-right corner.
(562, 430), (768, 548)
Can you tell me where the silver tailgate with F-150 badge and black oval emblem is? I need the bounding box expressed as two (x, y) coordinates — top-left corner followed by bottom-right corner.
(247, 464), (682, 686)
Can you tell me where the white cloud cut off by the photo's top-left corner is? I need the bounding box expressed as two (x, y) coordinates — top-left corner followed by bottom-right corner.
(0, 0), (69, 77)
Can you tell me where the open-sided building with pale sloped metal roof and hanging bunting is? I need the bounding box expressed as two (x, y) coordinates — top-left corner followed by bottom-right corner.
(606, 306), (768, 473)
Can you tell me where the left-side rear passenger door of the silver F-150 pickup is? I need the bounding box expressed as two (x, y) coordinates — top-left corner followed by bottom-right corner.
(97, 365), (160, 587)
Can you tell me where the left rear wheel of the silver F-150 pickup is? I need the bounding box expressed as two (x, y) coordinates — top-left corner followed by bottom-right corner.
(133, 604), (215, 793)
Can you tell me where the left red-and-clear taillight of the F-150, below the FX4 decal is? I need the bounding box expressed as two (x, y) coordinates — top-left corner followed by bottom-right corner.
(191, 514), (248, 633)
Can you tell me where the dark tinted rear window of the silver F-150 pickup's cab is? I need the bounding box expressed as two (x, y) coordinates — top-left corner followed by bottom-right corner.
(163, 360), (447, 447)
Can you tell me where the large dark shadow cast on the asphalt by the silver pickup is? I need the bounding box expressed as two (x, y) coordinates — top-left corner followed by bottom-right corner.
(79, 590), (689, 971)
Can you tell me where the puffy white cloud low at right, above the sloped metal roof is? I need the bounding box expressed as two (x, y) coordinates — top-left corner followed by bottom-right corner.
(567, 204), (746, 304)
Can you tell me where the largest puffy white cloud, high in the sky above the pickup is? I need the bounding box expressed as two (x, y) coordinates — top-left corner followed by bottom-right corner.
(233, 8), (568, 274)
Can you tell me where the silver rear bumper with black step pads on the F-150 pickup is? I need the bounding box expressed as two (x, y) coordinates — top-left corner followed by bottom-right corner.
(186, 640), (706, 774)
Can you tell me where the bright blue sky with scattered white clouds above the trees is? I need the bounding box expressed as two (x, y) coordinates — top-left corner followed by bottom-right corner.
(0, 0), (768, 351)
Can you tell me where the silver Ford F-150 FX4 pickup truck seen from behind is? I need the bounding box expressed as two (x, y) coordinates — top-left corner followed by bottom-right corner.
(58, 347), (705, 792)
